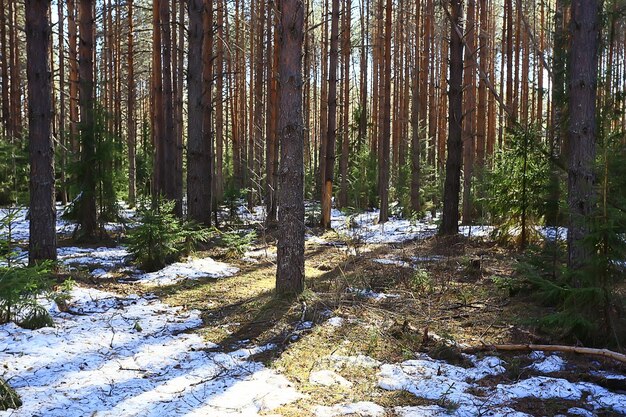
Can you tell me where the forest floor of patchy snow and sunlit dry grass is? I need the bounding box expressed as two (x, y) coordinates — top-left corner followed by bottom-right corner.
(0, 203), (626, 417)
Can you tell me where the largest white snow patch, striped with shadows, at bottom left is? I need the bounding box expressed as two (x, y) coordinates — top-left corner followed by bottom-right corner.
(0, 288), (300, 417)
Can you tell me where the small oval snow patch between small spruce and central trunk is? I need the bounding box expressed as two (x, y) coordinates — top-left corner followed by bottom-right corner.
(133, 258), (239, 285)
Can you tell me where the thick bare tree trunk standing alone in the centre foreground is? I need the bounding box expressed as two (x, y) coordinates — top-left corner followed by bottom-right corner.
(276, 0), (304, 295)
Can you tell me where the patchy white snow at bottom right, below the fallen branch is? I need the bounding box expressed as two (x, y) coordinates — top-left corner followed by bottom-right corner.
(378, 355), (626, 417)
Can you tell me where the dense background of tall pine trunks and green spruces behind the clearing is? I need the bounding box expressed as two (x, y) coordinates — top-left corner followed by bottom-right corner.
(0, 0), (626, 342)
